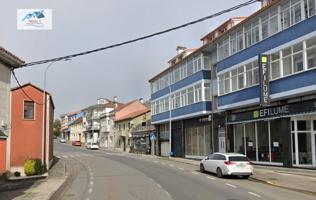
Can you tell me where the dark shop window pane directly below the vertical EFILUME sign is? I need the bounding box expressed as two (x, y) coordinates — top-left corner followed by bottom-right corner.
(257, 121), (270, 162)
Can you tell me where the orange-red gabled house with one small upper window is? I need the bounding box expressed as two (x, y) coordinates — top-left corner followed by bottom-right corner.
(9, 83), (55, 172)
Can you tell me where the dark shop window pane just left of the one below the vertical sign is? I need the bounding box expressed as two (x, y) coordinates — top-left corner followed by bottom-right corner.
(245, 123), (257, 160)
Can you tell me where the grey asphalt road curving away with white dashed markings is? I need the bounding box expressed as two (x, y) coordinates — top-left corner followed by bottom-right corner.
(55, 143), (315, 200)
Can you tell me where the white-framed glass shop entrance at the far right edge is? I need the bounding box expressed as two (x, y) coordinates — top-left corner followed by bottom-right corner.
(292, 116), (316, 166)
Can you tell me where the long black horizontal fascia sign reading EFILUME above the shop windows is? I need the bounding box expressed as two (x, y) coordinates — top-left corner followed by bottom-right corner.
(228, 100), (316, 123)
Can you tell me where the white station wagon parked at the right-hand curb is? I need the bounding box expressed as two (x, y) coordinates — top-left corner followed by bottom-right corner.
(200, 153), (253, 179)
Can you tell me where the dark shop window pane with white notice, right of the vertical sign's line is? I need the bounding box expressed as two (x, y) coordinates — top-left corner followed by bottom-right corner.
(270, 120), (283, 162)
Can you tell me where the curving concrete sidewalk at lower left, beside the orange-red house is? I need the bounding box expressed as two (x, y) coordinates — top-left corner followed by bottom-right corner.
(1, 160), (67, 200)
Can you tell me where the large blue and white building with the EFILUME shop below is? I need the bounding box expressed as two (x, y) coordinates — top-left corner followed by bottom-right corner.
(203, 0), (316, 167)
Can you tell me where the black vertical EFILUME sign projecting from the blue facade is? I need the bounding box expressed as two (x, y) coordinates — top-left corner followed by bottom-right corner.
(258, 55), (270, 106)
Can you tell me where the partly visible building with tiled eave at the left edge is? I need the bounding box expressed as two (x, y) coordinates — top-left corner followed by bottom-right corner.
(0, 47), (24, 173)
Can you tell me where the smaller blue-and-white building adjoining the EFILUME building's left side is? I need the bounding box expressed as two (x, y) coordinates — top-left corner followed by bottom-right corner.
(149, 46), (215, 157)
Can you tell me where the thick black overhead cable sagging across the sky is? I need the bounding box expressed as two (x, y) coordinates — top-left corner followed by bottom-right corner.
(19, 0), (257, 67)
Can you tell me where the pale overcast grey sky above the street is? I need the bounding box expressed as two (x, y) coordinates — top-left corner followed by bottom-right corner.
(0, 0), (260, 116)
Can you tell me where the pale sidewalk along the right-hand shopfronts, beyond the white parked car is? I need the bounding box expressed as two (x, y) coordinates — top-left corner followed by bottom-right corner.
(100, 148), (316, 195)
